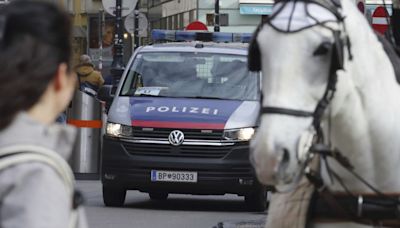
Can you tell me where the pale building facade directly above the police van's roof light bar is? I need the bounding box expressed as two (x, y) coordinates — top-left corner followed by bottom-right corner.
(148, 0), (273, 32)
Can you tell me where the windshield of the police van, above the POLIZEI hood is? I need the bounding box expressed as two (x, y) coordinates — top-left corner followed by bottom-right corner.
(121, 52), (260, 100)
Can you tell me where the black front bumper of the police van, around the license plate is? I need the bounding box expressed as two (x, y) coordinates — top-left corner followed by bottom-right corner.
(101, 137), (256, 195)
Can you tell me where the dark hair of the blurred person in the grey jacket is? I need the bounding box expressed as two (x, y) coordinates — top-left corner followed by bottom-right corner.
(0, 0), (71, 129)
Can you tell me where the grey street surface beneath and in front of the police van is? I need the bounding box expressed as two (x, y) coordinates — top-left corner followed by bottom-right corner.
(77, 181), (266, 228)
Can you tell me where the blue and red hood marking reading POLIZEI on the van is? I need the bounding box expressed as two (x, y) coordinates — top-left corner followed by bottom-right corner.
(130, 97), (242, 129)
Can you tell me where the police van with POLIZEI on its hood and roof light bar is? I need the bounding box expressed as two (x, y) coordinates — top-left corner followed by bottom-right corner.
(101, 30), (267, 211)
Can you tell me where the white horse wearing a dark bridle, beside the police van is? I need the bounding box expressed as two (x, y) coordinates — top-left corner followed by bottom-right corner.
(250, 0), (400, 227)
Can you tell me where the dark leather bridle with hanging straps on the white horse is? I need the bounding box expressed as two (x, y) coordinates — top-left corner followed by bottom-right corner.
(260, 0), (400, 224)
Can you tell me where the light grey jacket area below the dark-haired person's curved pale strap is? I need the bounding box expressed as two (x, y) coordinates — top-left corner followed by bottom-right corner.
(0, 162), (71, 227)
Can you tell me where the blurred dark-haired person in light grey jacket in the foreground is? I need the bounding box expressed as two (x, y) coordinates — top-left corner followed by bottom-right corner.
(0, 1), (87, 228)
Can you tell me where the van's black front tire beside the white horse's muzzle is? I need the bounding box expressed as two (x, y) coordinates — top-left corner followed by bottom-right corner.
(244, 183), (269, 212)
